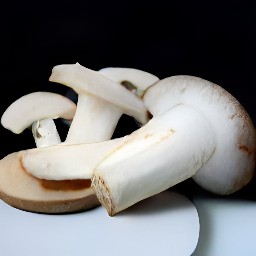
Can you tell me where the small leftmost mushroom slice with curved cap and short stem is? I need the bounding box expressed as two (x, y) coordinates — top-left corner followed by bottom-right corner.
(1, 92), (76, 147)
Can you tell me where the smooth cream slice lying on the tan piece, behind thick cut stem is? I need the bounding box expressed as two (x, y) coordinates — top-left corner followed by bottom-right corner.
(22, 137), (125, 180)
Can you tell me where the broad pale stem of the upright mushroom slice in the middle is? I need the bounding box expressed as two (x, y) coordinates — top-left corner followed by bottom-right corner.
(64, 94), (122, 144)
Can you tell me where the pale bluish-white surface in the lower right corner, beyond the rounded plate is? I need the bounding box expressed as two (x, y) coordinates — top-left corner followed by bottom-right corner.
(193, 197), (256, 256)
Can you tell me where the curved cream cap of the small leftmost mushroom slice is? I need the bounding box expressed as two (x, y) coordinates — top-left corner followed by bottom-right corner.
(1, 92), (76, 134)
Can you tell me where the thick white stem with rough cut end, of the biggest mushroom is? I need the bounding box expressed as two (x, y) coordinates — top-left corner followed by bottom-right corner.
(92, 105), (215, 216)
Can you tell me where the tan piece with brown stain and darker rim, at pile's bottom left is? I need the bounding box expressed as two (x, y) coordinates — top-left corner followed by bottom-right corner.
(0, 151), (99, 213)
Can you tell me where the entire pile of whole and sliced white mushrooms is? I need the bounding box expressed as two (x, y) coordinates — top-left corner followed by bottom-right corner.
(0, 63), (256, 216)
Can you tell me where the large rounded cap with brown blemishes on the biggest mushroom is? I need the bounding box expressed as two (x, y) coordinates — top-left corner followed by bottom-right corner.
(144, 75), (256, 195)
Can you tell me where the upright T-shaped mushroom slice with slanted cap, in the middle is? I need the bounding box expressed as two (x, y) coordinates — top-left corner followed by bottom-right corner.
(49, 63), (148, 144)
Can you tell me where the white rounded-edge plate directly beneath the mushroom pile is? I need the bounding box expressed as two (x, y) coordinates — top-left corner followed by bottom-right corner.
(0, 191), (199, 256)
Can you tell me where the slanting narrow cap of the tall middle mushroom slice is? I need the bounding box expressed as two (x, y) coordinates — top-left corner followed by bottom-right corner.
(49, 63), (148, 123)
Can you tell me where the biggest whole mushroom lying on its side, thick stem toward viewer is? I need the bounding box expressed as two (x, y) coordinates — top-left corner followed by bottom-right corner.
(89, 76), (256, 216)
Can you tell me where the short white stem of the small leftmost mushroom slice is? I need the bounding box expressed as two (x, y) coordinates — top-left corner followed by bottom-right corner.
(32, 118), (61, 147)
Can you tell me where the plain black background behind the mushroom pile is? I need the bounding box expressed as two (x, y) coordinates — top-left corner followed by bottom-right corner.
(0, 0), (256, 198)
